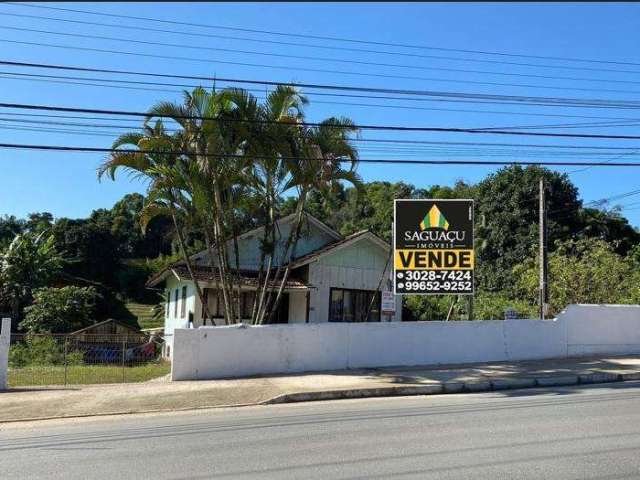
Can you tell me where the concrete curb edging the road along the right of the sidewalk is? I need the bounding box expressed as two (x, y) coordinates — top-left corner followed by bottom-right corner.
(262, 372), (640, 405)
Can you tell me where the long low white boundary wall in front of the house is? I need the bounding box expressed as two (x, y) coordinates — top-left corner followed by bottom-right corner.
(172, 305), (640, 380)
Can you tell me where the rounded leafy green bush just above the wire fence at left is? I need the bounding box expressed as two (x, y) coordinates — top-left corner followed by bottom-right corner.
(20, 286), (99, 333)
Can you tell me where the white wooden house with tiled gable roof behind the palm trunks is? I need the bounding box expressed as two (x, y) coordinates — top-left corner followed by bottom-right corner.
(147, 213), (402, 356)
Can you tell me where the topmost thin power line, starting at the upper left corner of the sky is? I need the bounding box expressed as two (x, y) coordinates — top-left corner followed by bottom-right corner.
(6, 2), (640, 70)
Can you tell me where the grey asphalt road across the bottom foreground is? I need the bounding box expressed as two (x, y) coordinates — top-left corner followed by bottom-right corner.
(0, 382), (640, 480)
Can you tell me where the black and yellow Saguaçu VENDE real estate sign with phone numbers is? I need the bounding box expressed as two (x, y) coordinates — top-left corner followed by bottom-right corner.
(393, 199), (475, 295)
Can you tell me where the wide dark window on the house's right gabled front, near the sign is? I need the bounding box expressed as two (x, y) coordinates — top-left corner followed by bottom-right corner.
(329, 288), (380, 322)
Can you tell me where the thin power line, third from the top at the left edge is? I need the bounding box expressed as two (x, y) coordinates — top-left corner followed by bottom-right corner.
(6, 23), (640, 89)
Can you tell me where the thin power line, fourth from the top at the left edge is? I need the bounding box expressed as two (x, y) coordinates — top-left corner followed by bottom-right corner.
(6, 38), (640, 94)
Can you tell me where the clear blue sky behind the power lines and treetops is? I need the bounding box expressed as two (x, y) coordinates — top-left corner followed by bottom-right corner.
(0, 3), (640, 225)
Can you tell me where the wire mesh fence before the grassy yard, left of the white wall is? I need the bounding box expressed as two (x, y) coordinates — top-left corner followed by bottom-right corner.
(7, 334), (171, 387)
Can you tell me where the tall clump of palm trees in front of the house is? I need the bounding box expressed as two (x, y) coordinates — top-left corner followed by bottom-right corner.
(99, 86), (360, 324)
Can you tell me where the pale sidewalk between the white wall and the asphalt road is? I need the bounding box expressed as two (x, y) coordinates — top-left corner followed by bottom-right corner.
(0, 355), (640, 422)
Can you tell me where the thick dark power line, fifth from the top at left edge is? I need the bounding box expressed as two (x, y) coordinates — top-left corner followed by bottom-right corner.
(0, 60), (640, 109)
